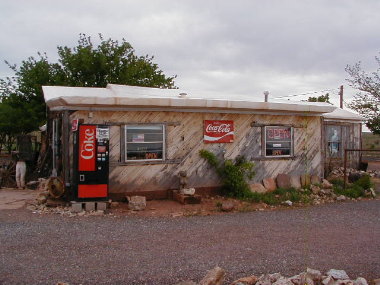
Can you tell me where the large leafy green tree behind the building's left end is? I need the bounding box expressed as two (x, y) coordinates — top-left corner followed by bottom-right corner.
(0, 34), (176, 132)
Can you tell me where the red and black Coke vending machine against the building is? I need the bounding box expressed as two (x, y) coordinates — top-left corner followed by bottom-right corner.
(74, 124), (109, 201)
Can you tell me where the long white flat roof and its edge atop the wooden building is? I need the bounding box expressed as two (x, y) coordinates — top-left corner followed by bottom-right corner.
(42, 84), (336, 115)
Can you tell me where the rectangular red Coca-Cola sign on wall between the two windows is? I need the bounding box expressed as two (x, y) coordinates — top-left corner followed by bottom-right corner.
(203, 120), (234, 143)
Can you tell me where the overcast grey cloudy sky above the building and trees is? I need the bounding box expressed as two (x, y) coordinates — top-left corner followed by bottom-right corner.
(0, 0), (380, 103)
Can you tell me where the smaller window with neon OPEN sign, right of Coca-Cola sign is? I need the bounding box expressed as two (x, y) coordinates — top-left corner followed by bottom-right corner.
(265, 126), (293, 156)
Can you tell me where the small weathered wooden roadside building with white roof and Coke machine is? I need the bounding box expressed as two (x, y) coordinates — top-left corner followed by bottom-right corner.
(43, 84), (360, 200)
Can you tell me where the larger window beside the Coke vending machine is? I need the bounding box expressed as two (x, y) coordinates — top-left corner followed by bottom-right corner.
(125, 125), (165, 161)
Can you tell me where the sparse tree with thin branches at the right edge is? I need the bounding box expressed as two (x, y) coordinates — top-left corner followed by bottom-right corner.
(346, 53), (380, 134)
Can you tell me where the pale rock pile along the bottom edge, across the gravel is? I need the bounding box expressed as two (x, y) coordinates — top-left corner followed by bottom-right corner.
(176, 267), (380, 285)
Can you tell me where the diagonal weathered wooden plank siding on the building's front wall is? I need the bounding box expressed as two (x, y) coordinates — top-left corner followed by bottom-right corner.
(70, 111), (323, 193)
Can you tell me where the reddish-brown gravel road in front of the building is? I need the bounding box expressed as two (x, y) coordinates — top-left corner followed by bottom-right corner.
(0, 200), (380, 285)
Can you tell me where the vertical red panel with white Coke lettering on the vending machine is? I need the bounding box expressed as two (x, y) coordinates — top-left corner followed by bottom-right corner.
(79, 125), (96, 171)
